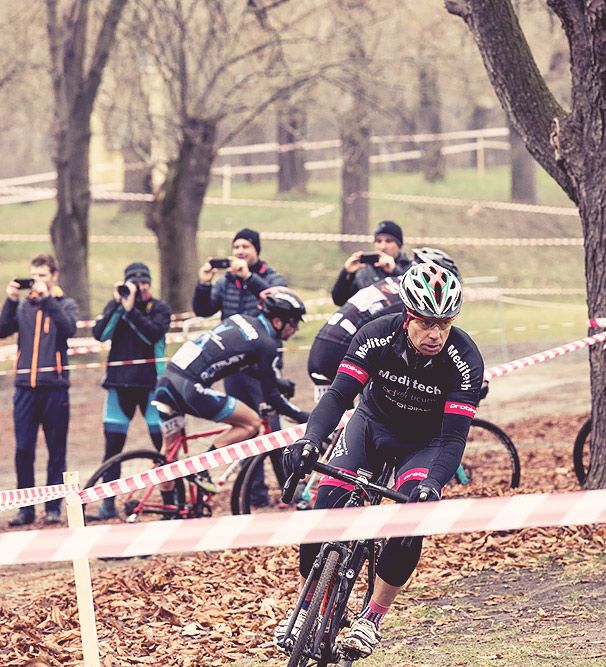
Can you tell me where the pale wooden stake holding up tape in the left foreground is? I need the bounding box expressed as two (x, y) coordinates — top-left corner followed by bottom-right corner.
(63, 472), (100, 667)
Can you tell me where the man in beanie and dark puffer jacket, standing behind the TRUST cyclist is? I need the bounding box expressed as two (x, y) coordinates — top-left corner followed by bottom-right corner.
(193, 228), (286, 507)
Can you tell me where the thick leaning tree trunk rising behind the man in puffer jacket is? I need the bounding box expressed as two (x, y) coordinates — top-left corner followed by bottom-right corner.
(146, 119), (217, 312)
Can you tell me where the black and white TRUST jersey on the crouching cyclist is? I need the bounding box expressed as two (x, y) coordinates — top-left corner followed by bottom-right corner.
(167, 315), (306, 422)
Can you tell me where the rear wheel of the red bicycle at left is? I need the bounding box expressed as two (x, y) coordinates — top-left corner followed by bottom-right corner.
(84, 449), (185, 521)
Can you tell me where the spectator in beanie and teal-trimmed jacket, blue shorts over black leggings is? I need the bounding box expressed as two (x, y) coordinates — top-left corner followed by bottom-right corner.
(87, 262), (172, 519)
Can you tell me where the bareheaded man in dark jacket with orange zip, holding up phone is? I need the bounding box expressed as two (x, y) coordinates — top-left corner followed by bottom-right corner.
(0, 253), (78, 526)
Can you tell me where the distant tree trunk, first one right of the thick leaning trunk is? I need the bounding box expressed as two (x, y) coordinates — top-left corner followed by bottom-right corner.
(278, 104), (307, 194)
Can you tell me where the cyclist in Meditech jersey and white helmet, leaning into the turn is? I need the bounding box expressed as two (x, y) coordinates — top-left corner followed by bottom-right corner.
(276, 263), (484, 657)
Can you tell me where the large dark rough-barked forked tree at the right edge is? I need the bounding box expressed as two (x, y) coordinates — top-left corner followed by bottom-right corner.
(445, 0), (606, 488)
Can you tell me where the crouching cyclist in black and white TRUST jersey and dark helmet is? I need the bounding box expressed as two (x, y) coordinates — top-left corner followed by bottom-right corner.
(154, 286), (309, 456)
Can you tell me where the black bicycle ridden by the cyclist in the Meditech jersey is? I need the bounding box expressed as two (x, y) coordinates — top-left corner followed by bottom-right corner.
(280, 462), (408, 667)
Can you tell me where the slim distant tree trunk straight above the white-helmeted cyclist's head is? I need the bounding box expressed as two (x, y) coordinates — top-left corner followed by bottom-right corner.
(419, 65), (446, 183)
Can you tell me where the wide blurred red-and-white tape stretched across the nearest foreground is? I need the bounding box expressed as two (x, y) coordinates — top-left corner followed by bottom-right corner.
(0, 490), (606, 565)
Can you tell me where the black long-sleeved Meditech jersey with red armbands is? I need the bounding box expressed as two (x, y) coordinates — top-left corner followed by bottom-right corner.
(306, 314), (484, 486)
